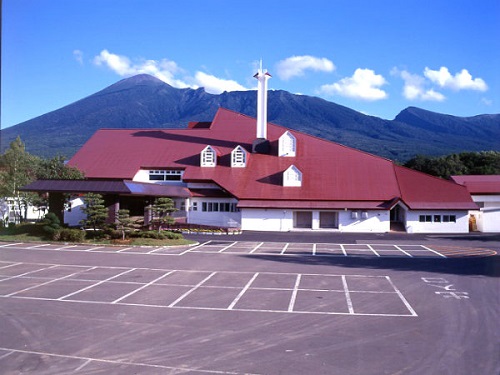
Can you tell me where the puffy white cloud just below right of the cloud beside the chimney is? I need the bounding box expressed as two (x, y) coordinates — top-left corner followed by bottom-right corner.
(319, 68), (388, 101)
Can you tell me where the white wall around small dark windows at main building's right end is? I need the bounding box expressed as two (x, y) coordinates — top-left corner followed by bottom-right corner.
(406, 211), (469, 233)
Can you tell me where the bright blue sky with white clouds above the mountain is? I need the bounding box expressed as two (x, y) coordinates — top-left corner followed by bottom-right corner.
(1, 0), (500, 128)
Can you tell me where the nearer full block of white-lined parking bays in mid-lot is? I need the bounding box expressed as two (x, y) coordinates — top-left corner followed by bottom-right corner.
(0, 262), (417, 317)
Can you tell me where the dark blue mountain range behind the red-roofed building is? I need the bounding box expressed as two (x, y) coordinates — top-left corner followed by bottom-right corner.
(1, 74), (500, 161)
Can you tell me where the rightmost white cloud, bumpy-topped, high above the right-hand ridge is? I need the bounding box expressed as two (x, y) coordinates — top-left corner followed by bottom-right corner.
(424, 66), (488, 91)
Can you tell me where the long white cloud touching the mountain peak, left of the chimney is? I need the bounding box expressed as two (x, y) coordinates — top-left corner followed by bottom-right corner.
(94, 50), (189, 88)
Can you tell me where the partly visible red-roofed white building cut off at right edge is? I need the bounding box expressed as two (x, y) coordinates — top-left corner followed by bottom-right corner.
(451, 175), (500, 233)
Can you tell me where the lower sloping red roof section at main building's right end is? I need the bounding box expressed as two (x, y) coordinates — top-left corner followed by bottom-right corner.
(394, 165), (477, 210)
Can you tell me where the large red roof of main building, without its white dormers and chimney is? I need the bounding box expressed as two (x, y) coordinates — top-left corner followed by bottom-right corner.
(69, 108), (473, 209)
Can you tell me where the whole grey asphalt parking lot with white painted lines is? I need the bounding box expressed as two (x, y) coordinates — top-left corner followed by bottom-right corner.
(0, 234), (500, 374)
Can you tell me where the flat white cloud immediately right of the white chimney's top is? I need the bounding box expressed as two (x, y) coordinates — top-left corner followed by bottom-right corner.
(276, 55), (335, 81)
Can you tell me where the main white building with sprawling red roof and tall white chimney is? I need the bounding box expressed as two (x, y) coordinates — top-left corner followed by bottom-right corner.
(26, 69), (477, 233)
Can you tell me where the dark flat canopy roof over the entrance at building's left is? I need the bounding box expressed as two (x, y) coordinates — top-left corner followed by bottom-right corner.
(20, 180), (191, 198)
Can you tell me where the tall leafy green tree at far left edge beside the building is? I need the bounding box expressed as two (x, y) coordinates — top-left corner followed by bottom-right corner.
(0, 137), (40, 222)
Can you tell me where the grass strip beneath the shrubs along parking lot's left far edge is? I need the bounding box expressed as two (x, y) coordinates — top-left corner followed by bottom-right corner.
(0, 224), (195, 246)
